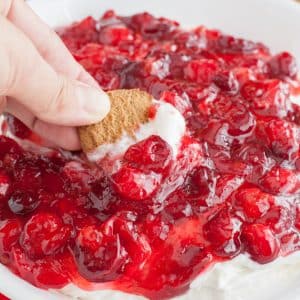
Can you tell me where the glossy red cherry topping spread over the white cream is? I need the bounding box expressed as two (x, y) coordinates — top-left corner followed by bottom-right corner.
(0, 11), (300, 299)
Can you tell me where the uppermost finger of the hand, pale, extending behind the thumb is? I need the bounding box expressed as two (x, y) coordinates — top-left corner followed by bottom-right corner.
(0, 0), (99, 88)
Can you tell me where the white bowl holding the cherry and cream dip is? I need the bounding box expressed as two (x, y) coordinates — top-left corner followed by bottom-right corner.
(0, 0), (300, 300)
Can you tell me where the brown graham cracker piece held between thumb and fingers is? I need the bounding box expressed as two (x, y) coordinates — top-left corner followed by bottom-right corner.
(78, 89), (152, 153)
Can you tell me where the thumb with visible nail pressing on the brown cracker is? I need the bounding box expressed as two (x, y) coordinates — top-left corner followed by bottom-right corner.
(0, 16), (110, 126)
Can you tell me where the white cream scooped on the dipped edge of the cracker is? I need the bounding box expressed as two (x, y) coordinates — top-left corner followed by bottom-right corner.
(88, 100), (185, 161)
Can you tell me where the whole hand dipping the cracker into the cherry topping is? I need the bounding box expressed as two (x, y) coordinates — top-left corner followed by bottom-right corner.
(0, 0), (110, 150)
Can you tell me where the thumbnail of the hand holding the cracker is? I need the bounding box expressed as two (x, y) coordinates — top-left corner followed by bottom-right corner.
(76, 84), (110, 122)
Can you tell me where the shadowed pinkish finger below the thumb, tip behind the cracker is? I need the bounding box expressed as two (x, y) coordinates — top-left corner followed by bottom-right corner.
(5, 98), (80, 150)
